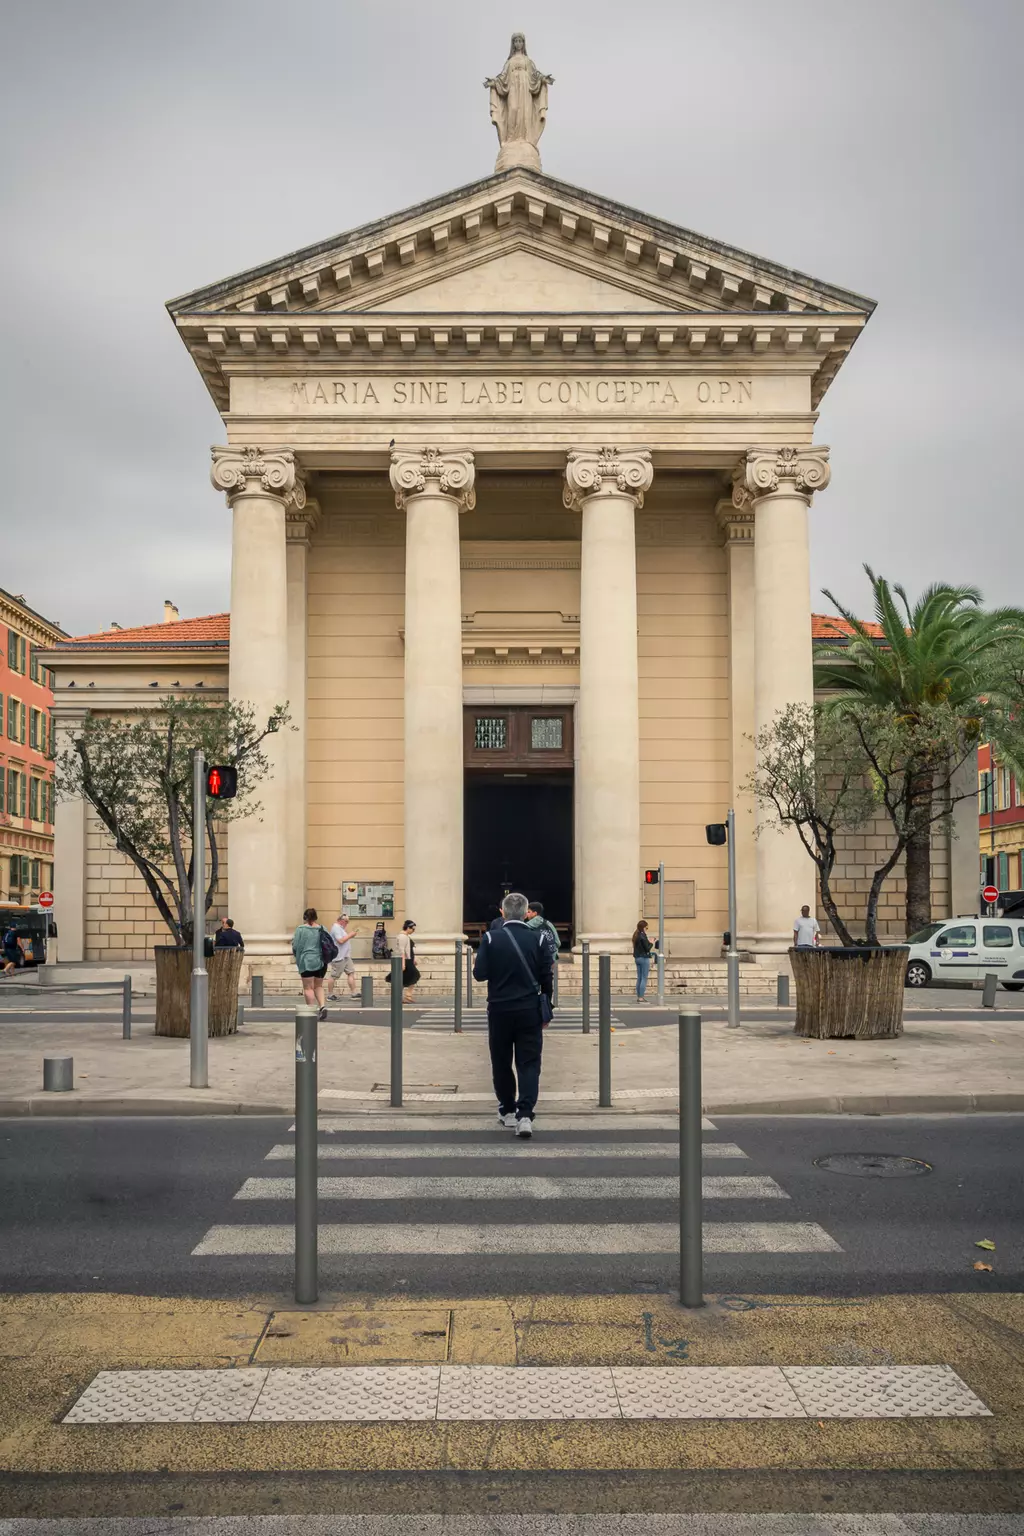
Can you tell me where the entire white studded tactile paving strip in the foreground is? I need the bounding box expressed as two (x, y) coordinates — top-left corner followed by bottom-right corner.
(63, 1366), (992, 1424)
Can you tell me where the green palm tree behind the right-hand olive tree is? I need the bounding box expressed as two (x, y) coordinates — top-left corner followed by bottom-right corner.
(815, 565), (1024, 934)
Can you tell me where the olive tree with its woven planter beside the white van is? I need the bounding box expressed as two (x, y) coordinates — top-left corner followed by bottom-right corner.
(749, 699), (981, 1038)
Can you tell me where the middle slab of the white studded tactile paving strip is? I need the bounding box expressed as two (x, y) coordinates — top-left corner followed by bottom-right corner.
(438, 1366), (622, 1421)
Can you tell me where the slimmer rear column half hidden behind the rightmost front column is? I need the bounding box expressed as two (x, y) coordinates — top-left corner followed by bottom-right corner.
(715, 492), (757, 948)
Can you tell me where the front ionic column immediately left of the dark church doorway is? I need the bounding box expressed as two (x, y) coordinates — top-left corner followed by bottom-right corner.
(391, 449), (476, 954)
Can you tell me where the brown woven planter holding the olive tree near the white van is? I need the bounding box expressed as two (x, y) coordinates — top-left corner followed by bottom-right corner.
(789, 945), (910, 1040)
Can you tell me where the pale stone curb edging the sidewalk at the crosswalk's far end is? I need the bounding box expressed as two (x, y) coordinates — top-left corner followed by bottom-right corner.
(0, 1091), (1024, 1121)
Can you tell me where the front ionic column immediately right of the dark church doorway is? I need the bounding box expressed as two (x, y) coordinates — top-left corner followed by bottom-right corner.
(562, 449), (654, 952)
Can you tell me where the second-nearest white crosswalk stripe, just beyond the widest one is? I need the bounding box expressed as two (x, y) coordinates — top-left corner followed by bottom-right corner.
(235, 1173), (789, 1201)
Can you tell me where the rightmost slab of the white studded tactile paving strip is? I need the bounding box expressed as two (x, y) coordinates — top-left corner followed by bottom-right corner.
(783, 1366), (990, 1419)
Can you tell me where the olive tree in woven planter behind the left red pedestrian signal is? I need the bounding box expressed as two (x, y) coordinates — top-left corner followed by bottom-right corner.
(57, 694), (289, 1035)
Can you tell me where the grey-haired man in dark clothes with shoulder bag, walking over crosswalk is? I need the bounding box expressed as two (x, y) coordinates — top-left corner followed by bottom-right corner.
(473, 891), (551, 1137)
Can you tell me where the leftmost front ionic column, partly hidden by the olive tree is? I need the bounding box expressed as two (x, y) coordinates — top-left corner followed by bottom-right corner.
(210, 449), (306, 955)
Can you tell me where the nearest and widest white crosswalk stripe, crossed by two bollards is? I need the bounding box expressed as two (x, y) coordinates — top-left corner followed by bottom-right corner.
(192, 1221), (843, 1258)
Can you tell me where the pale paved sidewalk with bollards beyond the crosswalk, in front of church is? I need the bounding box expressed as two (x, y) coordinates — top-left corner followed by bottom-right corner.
(0, 1009), (1024, 1115)
